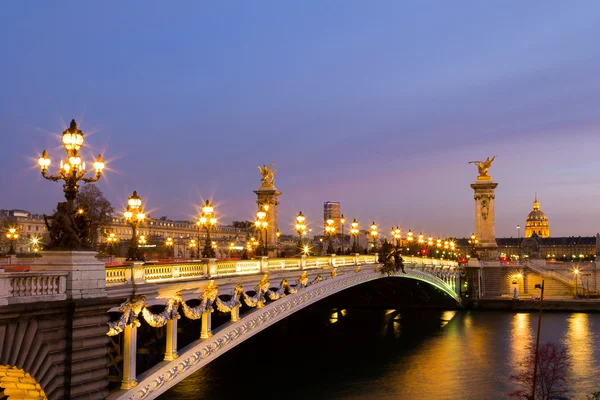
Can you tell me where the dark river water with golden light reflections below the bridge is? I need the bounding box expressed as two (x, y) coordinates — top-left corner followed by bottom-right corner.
(161, 307), (600, 400)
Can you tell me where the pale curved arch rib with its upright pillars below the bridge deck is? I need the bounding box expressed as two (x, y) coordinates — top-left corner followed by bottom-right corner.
(109, 264), (461, 400)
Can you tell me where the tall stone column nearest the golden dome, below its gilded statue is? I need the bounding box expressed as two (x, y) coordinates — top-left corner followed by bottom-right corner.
(471, 176), (498, 260)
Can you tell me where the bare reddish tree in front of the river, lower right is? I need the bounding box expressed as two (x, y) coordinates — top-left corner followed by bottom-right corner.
(508, 342), (571, 400)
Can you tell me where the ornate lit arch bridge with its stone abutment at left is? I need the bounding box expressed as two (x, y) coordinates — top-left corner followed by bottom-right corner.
(0, 252), (464, 399)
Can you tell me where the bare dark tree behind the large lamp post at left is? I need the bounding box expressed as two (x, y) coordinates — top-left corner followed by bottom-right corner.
(75, 183), (115, 247)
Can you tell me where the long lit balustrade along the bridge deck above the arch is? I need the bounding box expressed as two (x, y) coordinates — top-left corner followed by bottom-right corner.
(106, 254), (458, 287)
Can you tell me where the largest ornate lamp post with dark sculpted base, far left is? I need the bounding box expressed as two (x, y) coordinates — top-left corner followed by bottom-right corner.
(38, 120), (104, 249)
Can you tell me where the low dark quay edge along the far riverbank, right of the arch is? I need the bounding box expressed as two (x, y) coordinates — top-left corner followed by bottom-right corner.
(475, 299), (600, 312)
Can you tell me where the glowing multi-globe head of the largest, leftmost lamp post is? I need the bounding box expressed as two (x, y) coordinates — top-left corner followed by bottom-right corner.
(38, 120), (104, 212)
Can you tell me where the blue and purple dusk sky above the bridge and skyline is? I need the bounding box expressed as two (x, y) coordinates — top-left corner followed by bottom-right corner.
(0, 0), (600, 237)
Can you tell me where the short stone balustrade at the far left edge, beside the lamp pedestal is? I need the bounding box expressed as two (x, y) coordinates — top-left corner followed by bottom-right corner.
(0, 271), (69, 305)
